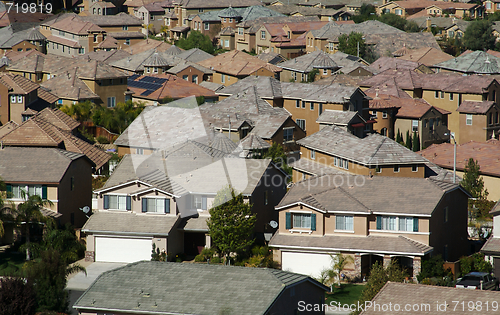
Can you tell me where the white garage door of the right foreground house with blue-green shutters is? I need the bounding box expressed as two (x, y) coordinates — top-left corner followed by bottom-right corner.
(281, 252), (332, 278)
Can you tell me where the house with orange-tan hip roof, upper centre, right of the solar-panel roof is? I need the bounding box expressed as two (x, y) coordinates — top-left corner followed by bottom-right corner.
(198, 50), (282, 86)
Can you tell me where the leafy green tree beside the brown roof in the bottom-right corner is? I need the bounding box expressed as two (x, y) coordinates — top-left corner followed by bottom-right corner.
(351, 262), (408, 314)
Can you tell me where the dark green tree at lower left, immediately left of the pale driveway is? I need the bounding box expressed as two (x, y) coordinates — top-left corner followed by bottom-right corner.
(24, 249), (85, 312)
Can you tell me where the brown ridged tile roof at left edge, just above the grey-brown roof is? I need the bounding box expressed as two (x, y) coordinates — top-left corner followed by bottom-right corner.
(0, 108), (111, 174)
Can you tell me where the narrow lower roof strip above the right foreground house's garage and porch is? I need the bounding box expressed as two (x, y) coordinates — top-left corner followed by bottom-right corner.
(269, 234), (433, 256)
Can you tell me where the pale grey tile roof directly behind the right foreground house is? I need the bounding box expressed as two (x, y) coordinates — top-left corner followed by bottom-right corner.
(297, 126), (427, 165)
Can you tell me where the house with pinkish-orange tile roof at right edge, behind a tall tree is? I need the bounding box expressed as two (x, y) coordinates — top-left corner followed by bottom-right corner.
(418, 139), (500, 201)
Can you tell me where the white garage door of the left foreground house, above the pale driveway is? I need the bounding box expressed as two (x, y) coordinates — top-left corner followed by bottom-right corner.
(95, 236), (152, 263)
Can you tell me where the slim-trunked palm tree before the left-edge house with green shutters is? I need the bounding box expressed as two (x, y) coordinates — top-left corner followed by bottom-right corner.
(14, 193), (51, 260)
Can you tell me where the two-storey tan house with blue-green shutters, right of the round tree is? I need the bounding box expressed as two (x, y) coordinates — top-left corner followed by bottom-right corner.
(269, 174), (469, 279)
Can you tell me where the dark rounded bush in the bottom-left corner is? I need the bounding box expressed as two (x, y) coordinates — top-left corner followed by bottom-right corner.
(0, 277), (36, 315)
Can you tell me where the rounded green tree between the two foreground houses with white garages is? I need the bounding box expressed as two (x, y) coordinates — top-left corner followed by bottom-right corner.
(207, 189), (257, 261)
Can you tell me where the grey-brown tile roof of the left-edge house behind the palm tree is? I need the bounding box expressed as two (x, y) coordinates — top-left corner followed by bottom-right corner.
(0, 147), (84, 183)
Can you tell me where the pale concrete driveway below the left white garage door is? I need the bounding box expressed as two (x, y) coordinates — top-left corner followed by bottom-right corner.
(66, 260), (127, 314)
